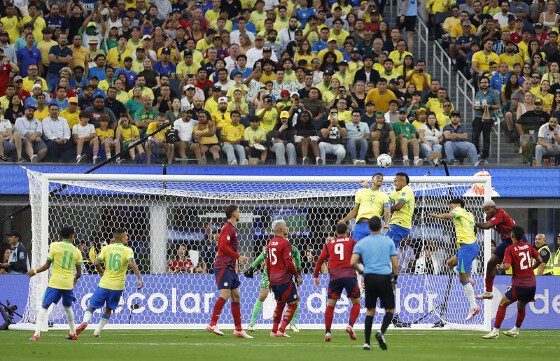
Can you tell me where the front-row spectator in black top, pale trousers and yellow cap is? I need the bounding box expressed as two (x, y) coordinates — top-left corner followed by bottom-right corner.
(267, 110), (297, 165)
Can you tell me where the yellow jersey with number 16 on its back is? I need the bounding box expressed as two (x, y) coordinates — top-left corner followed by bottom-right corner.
(97, 242), (135, 291)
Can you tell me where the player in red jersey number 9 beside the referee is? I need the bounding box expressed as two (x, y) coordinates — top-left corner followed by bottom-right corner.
(313, 220), (360, 342)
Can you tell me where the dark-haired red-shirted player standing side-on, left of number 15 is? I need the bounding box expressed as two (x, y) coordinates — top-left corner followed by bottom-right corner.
(206, 205), (253, 338)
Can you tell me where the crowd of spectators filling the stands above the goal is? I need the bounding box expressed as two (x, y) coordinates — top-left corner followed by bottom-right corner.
(0, 0), (560, 166)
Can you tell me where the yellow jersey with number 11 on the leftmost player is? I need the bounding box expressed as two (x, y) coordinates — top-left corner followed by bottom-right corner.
(47, 241), (82, 290)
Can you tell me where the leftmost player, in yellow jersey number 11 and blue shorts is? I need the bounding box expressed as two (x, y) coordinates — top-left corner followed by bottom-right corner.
(27, 227), (82, 341)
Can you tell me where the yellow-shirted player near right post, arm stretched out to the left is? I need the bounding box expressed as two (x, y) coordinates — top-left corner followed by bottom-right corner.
(428, 198), (480, 321)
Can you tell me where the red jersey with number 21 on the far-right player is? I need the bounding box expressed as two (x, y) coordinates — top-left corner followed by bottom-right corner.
(503, 242), (539, 287)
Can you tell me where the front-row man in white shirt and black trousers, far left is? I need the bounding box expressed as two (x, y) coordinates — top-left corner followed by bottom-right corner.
(42, 103), (73, 162)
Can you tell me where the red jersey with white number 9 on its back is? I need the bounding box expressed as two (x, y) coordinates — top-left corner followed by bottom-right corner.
(314, 237), (358, 281)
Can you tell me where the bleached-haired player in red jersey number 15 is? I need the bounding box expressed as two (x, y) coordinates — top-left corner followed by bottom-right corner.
(266, 219), (303, 337)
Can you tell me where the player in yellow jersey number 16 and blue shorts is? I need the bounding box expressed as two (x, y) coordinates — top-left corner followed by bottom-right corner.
(76, 228), (143, 337)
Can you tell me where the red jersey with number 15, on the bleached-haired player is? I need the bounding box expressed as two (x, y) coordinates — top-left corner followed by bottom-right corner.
(266, 237), (298, 286)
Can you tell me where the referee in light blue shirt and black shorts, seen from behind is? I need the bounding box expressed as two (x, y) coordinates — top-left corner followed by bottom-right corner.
(350, 217), (399, 350)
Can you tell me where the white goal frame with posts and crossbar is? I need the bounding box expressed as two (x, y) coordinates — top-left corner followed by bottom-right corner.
(19, 173), (492, 331)
